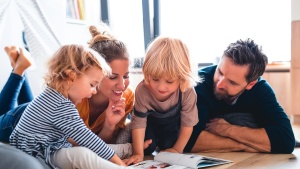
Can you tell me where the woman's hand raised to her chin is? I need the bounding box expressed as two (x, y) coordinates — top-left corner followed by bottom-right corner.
(105, 97), (125, 127)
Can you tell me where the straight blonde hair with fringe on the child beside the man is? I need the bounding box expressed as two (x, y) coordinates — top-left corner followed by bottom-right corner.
(142, 37), (198, 92)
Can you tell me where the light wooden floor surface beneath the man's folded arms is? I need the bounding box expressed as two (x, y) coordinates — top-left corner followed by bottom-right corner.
(147, 148), (300, 169)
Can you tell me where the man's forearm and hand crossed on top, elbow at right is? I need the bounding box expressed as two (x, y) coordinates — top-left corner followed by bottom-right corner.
(206, 119), (271, 152)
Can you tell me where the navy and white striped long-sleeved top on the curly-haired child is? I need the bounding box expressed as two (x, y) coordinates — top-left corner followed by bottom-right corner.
(10, 87), (114, 167)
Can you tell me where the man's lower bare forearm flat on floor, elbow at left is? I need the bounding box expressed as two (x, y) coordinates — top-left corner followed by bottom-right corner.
(191, 131), (258, 153)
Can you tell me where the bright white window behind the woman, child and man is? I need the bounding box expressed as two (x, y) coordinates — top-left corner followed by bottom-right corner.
(109, 0), (291, 66)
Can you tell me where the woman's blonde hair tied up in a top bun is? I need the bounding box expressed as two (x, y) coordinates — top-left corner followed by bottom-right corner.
(88, 26), (129, 63)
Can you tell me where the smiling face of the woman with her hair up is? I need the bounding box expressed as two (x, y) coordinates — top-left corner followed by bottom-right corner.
(97, 59), (129, 101)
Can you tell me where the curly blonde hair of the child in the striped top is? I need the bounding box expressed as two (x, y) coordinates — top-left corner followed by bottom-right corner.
(45, 45), (111, 92)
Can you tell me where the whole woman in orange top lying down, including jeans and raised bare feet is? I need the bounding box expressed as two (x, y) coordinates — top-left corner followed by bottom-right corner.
(0, 26), (150, 158)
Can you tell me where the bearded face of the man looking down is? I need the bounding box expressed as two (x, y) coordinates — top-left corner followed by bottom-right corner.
(214, 56), (255, 101)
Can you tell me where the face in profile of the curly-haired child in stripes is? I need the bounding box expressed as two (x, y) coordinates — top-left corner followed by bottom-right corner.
(68, 66), (103, 105)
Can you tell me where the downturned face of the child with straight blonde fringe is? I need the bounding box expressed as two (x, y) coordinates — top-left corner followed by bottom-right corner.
(149, 76), (179, 101)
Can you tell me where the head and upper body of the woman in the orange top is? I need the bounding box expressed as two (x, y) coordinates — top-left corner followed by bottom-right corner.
(77, 26), (134, 144)
